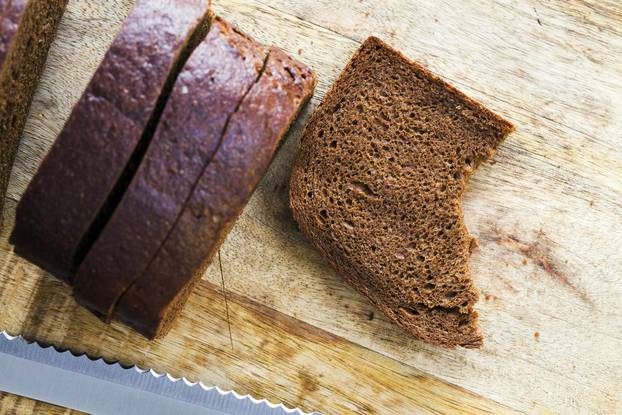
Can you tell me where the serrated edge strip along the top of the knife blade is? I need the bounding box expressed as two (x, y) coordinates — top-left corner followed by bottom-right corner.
(0, 331), (319, 415)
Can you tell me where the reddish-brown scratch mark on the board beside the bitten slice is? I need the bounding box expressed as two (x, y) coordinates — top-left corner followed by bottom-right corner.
(482, 227), (593, 305)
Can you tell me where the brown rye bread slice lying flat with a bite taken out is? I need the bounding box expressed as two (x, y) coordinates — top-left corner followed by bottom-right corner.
(290, 37), (513, 347)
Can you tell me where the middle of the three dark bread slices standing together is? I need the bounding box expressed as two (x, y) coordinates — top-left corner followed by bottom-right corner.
(74, 18), (266, 319)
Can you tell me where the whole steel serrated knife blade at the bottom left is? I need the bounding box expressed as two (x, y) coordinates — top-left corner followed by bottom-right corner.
(0, 332), (320, 415)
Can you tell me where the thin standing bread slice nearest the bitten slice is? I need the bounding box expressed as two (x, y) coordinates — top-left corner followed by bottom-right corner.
(115, 48), (315, 338)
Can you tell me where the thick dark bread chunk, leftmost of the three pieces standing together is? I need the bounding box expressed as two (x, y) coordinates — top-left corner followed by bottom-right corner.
(11, 0), (209, 281)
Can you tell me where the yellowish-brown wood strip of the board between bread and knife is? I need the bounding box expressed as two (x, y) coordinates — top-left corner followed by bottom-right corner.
(0, 200), (515, 414)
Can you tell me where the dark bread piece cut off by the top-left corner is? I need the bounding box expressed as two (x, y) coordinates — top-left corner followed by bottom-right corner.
(0, 0), (67, 226)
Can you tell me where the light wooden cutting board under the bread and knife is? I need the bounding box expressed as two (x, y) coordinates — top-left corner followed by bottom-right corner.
(0, 0), (622, 414)
